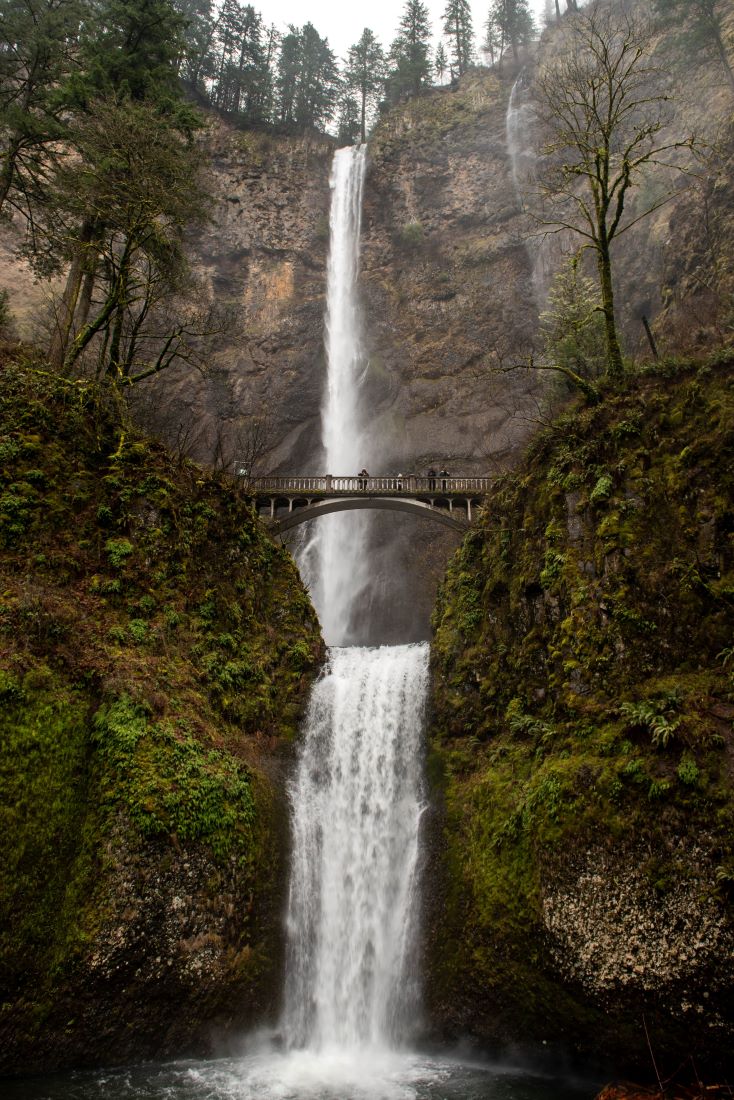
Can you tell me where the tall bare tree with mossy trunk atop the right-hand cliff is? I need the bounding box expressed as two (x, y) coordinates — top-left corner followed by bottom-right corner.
(536, 3), (693, 378)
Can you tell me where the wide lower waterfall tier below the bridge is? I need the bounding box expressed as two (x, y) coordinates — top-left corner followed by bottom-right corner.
(284, 645), (428, 1051)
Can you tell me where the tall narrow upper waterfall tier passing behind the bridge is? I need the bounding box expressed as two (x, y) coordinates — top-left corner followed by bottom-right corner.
(299, 145), (369, 646)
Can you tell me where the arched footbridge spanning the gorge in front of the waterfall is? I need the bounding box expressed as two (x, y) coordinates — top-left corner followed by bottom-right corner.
(242, 475), (493, 535)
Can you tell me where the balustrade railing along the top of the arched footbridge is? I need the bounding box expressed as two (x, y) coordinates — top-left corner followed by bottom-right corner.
(244, 466), (494, 496)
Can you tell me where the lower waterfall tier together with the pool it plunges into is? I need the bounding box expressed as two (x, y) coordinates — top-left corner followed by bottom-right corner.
(3, 645), (598, 1100)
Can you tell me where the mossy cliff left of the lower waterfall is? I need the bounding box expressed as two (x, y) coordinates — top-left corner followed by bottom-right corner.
(0, 361), (322, 1071)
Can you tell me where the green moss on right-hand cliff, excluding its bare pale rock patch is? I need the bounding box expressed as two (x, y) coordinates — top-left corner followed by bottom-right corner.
(430, 359), (734, 1056)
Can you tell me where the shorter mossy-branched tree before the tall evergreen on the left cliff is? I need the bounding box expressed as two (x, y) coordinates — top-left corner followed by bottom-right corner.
(52, 97), (205, 388)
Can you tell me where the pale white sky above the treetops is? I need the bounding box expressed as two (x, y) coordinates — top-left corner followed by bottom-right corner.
(253, 0), (545, 61)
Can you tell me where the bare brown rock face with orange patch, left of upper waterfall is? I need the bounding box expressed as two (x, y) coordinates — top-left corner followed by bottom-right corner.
(162, 122), (333, 472)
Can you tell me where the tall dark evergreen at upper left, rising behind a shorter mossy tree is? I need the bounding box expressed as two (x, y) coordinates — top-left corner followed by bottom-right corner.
(46, 0), (200, 366)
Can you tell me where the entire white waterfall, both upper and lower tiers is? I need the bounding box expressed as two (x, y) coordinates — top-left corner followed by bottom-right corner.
(283, 147), (428, 1054)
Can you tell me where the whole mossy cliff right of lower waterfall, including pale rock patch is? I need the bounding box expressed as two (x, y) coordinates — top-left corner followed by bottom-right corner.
(426, 361), (734, 1071)
